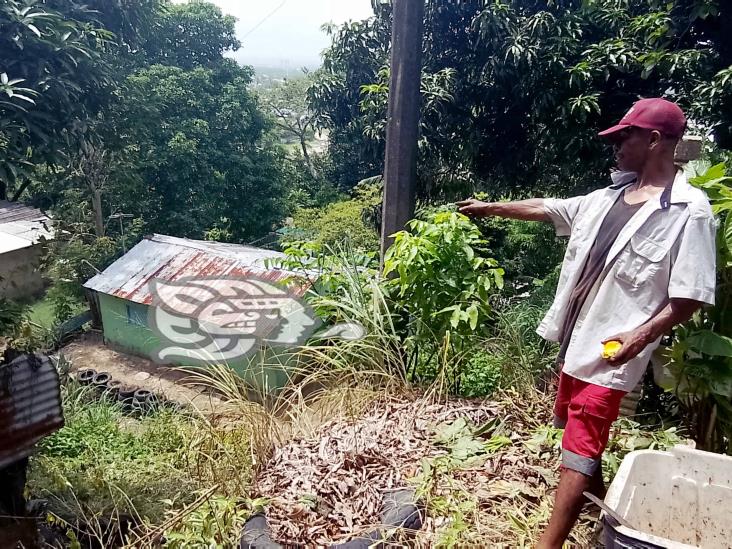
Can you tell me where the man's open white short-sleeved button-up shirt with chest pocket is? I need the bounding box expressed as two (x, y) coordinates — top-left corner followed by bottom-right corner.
(537, 171), (717, 392)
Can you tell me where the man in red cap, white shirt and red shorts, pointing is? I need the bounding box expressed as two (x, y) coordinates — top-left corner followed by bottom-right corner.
(458, 98), (716, 549)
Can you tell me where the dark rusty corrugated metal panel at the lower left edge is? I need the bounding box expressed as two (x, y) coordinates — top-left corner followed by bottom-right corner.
(0, 355), (64, 468)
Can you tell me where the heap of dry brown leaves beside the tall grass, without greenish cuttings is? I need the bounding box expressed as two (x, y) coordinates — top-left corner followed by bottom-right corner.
(257, 400), (497, 547)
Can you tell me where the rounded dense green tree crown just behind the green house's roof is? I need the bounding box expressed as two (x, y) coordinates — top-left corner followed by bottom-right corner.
(108, 65), (286, 241)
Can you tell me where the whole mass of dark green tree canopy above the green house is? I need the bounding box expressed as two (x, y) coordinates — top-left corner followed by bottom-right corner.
(12, 0), (286, 241)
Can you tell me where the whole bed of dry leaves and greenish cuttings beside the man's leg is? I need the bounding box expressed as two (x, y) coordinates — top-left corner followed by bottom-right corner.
(256, 388), (600, 547)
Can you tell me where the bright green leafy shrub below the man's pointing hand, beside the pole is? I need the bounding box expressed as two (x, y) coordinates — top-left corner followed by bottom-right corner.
(383, 212), (503, 386)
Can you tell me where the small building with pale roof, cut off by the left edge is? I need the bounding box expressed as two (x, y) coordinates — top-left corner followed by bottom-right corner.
(0, 200), (53, 300)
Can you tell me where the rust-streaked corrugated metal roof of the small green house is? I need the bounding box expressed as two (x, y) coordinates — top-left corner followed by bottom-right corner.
(84, 234), (306, 305)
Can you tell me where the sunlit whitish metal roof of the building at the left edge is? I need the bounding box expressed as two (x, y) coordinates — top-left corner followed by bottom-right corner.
(0, 200), (53, 254)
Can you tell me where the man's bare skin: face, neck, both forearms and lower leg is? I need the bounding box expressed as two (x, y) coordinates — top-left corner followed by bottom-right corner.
(457, 127), (702, 549)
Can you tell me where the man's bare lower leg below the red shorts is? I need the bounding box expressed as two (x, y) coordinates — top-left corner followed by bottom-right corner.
(536, 467), (605, 549)
